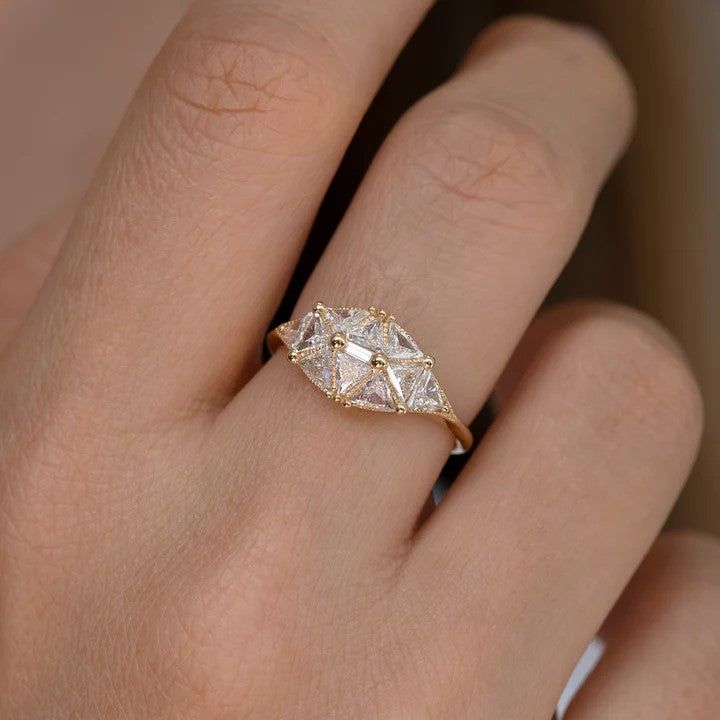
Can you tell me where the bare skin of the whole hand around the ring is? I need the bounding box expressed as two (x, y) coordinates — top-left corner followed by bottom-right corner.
(0, 0), (720, 720)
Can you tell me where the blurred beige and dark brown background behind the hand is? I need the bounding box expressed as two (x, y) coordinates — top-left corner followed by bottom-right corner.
(0, 0), (720, 534)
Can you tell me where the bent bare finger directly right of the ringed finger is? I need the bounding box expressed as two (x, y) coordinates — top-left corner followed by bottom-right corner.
(408, 304), (701, 718)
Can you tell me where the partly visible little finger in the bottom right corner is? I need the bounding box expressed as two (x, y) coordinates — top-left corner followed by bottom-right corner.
(566, 534), (720, 720)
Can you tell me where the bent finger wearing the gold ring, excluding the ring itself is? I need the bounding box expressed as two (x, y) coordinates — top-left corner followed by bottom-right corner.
(227, 18), (632, 537)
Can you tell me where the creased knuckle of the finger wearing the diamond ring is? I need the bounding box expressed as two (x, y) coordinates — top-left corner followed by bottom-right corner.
(401, 97), (572, 237)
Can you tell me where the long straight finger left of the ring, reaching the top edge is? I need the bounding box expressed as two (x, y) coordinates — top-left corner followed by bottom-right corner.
(4, 0), (429, 412)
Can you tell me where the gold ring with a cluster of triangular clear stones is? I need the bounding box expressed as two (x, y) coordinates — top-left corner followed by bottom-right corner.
(267, 302), (473, 454)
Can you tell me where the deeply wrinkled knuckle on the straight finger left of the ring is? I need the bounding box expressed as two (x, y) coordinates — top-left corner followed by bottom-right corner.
(158, 10), (338, 154)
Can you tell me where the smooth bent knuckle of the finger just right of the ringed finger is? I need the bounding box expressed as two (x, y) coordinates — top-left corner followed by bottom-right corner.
(544, 303), (703, 443)
